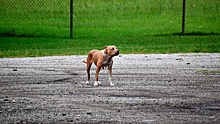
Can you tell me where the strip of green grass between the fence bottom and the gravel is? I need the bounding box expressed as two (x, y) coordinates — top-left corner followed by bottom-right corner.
(0, 35), (220, 58)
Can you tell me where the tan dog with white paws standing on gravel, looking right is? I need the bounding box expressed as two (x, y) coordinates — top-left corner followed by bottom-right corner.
(83, 46), (119, 86)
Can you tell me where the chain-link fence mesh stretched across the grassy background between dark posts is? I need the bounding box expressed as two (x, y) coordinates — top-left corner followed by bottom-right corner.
(0, 0), (220, 39)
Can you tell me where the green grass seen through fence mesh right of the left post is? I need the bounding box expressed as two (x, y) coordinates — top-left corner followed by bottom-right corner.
(75, 0), (220, 38)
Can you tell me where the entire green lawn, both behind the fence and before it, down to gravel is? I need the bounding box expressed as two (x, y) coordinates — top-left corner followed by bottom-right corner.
(0, 0), (220, 57)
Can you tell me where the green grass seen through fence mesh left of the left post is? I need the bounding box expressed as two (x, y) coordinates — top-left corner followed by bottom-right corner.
(0, 0), (69, 37)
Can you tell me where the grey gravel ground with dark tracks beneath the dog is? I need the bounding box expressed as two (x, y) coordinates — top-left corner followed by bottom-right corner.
(0, 53), (220, 124)
